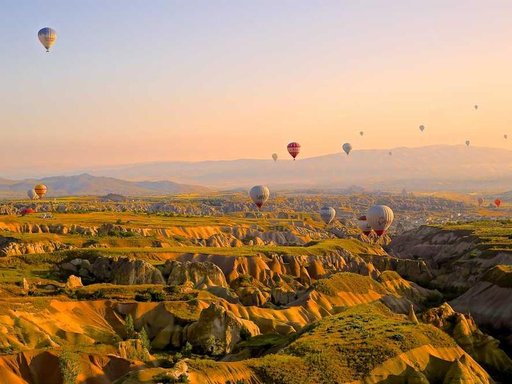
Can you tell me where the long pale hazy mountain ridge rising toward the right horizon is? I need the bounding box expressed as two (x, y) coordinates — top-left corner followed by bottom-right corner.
(86, 145), (512, 192)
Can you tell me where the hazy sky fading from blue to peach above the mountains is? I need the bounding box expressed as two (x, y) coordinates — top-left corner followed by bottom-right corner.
(0, 0), (512, 176)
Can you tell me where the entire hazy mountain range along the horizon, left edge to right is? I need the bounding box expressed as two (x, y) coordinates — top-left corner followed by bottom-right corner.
(0, 145), (512, 197)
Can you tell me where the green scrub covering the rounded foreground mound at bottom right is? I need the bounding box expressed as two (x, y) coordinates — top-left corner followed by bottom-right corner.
(250, 304), (456, 384)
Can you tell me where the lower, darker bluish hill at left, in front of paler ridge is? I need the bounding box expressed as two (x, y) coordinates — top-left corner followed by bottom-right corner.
(0, 173), (210, 197)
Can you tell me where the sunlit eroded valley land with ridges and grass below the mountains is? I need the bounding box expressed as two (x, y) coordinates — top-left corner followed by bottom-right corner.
(0, 194), (512, 384)
